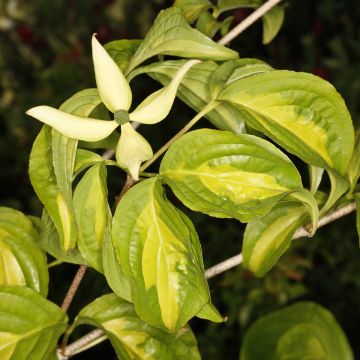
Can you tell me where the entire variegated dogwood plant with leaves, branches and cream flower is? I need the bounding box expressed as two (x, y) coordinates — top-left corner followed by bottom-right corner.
(0, 0), (360, 360)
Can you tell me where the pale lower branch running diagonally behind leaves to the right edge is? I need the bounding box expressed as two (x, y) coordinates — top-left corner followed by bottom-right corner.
(59, 203), (356, 359)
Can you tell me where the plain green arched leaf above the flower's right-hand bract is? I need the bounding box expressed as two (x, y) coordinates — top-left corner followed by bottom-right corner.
(127, 7), (238, 74)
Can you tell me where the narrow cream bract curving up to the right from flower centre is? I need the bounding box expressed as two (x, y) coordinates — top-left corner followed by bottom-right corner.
(130, 60), (201, 124)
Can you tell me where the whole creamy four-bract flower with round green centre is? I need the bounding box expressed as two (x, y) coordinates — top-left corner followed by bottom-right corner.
(26, 34), (200, 180)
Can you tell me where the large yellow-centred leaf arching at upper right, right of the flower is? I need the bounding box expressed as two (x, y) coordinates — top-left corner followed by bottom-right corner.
(219, 70), (354, 176)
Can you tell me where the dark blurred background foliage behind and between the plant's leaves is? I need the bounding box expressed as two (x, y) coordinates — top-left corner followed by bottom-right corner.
(0, 0), (360, 359)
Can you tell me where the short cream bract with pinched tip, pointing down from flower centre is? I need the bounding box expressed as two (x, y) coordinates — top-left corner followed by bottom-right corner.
(116, 123), (153, 180)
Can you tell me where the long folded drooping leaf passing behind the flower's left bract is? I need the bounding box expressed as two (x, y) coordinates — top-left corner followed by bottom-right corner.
(29, 89), (105, 251)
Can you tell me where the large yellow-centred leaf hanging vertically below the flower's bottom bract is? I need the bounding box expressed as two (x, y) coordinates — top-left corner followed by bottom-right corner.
(112, 178), (215, 332)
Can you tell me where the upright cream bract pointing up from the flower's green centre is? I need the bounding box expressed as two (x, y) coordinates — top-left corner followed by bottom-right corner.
(92, 34), (132, 113)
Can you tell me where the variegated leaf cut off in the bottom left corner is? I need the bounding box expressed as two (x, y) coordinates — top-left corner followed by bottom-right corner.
(0, 285), (67, 360)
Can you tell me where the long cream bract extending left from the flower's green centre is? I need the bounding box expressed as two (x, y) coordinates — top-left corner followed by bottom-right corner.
(26, 106), (118, 141)
